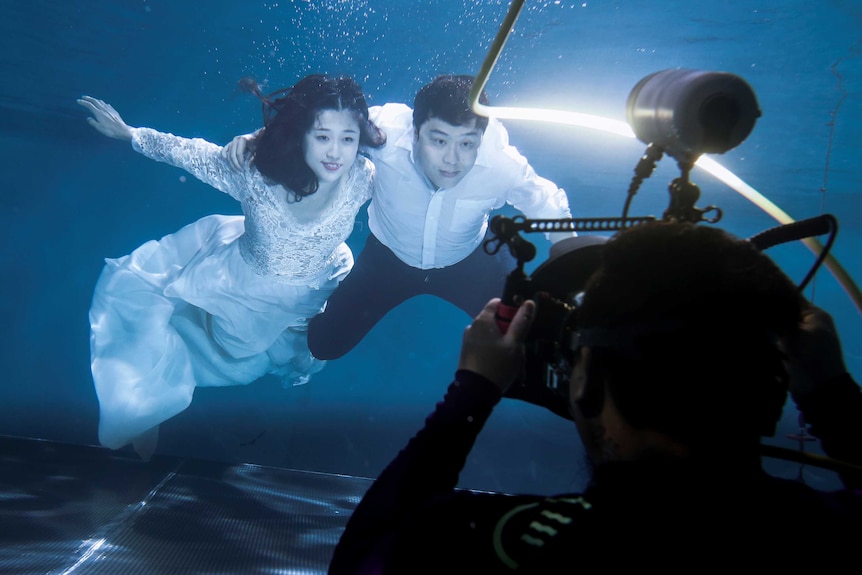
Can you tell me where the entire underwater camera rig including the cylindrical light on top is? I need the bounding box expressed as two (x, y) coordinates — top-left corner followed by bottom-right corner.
(490, 70), (837, 419)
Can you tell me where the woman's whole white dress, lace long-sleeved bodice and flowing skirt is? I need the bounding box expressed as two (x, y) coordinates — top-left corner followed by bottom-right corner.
(90, 128), (374, 459)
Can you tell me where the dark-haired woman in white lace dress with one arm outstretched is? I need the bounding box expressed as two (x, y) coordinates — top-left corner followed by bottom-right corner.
(78, 75), (385, 459)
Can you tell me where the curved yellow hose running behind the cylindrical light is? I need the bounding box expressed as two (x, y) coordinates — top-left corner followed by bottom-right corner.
(469, 0), (862, 313)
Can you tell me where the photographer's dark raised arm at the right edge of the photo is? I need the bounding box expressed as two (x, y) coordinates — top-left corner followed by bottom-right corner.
(790, 306), (862, 489)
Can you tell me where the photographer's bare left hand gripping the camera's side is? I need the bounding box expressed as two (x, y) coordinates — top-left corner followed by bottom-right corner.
(458, 298), (535, 393)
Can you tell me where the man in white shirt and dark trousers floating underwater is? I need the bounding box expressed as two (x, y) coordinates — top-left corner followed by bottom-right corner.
(308, 75), (574, 360)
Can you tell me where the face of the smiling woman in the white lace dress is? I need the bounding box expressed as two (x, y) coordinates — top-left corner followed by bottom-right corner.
(302, 110), (359, 185)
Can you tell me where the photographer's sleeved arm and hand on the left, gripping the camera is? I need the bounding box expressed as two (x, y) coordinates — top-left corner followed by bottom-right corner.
(329, 300), (533, 574)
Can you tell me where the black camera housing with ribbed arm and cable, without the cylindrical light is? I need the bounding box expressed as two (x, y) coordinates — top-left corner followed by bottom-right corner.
(484, 210), (838, 419)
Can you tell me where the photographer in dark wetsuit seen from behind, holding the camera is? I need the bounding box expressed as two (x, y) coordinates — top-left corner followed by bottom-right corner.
(330, 222), (862, 574)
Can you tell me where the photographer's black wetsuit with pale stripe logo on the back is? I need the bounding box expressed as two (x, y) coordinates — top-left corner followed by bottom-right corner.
(330, 371), (862, 575)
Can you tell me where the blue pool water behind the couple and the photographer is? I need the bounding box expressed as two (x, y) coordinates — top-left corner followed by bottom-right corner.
(0, 0), (862, 492)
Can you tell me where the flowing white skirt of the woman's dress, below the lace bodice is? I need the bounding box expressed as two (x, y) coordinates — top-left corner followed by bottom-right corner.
(90, 215), (353, 459)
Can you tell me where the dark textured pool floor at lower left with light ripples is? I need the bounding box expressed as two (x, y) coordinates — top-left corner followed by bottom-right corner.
(0, 437), (370, 575)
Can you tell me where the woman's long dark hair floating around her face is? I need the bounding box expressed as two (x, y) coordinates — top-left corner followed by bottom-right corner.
(239, 74), (386, 201)
